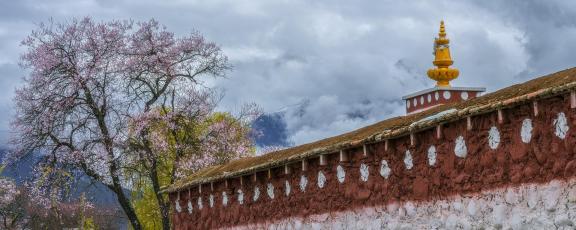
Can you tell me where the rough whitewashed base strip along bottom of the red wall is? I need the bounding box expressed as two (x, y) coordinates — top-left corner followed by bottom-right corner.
(227, 179), (576, 229)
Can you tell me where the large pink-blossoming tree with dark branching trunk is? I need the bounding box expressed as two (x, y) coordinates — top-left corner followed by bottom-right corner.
(11, 18), (229, 229)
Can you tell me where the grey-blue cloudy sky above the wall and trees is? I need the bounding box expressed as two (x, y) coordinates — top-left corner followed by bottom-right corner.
(0, 0), (576, 147)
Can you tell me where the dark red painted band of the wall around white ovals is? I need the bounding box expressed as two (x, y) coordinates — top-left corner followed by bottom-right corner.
(170, 92), (576, 229)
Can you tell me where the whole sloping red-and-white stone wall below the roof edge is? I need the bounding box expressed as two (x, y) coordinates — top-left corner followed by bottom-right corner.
(170, 94), (576, 229)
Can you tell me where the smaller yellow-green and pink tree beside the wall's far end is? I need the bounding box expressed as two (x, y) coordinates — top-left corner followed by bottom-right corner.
(127, 91), (260, 229)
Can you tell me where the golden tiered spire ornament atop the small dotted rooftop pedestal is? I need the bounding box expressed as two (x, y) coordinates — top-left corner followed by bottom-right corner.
(428, 21), (460, 87)
